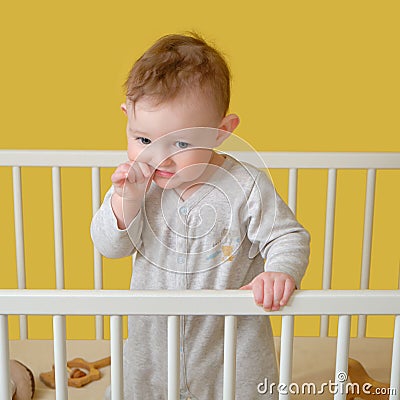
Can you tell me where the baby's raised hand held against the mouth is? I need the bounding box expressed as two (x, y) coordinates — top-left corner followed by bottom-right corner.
(111, 162), (154, 202)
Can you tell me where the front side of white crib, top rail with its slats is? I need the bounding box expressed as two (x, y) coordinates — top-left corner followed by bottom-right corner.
(0, 290), (400, 400)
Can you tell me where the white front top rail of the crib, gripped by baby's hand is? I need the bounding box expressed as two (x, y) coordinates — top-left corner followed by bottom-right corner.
(0, 289), (400, 315)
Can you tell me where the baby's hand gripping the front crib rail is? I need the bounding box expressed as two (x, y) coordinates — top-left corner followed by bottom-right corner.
(240, 272), (296, 311)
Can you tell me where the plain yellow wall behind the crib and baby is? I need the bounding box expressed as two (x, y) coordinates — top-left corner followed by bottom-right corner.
(0, 0), (400, 338)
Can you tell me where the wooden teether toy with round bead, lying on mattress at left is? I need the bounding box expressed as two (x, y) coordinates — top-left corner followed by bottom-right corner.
(39, 357), (111, 389)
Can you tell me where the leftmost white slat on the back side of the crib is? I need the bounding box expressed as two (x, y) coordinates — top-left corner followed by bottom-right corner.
(12, 167), (28, 340)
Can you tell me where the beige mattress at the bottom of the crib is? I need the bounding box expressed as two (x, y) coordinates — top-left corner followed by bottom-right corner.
(10, 337), (392, 400)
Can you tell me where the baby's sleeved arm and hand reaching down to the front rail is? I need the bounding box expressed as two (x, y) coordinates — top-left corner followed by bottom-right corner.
(241, 173), (310, 311)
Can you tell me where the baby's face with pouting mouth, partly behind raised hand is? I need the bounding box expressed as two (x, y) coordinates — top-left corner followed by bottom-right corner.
(122, 96), (229, 190)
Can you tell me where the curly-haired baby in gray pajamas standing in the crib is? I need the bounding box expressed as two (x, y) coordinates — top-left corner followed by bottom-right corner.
(91, 34), (309, 400)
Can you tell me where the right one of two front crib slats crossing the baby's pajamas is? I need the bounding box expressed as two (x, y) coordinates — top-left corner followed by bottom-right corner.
(223, 315), (237, 400)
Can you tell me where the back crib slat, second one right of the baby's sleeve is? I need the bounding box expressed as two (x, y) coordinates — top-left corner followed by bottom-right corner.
(320, 168), (337, 337)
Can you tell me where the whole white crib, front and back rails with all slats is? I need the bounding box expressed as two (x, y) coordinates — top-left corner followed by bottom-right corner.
(0, 150), (400, 400)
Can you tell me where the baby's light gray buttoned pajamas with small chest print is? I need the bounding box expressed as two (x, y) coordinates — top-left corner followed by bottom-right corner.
(91, 157), (309, 400)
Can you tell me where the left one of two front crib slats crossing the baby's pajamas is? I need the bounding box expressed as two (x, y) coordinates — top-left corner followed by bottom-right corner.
(168, 315), (180, 400)
